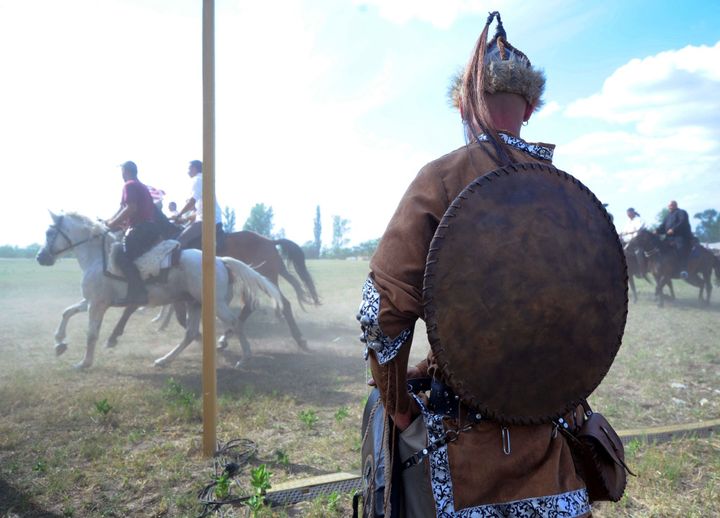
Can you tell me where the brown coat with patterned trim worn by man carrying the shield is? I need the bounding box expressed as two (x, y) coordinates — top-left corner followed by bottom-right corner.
(360, 135), (590, 516)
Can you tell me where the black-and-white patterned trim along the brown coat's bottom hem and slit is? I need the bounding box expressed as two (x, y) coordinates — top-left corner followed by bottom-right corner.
(413, 395), (592, 518)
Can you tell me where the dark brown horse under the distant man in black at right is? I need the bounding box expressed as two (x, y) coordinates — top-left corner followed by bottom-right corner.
(631, 229), (720, 307)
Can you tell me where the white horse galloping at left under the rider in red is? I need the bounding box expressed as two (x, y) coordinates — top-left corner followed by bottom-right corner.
(37, 212), (282, 369)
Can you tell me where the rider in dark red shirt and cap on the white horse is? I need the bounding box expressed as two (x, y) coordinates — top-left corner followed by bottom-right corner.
(106, 161), (160, 305)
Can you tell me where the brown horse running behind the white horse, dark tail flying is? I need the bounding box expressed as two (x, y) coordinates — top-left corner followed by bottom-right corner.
(106, 230), (320, 350)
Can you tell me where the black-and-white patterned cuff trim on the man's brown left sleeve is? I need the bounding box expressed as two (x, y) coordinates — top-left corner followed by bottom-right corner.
(358, 277), (412, 365)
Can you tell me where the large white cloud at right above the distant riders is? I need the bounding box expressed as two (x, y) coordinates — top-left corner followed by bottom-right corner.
(556, 42), (720, 225)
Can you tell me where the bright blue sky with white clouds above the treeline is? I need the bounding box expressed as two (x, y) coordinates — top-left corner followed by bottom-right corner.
(0, 0), (720, 246)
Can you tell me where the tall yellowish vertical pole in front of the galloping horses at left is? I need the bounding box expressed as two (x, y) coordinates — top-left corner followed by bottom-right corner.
(202, 0), (217, 457)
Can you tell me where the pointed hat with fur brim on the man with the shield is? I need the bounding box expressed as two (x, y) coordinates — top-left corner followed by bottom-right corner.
(448, 13), (545, 109)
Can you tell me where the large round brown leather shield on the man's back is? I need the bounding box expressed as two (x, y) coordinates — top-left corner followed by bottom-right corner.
(423, 164), (627, 424)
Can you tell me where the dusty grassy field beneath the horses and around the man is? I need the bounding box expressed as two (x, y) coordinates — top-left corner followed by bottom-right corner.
(0, 260), (720, 518)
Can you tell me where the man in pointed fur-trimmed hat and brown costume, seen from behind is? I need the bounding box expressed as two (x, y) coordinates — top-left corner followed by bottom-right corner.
(357, 13), (592, 518)
